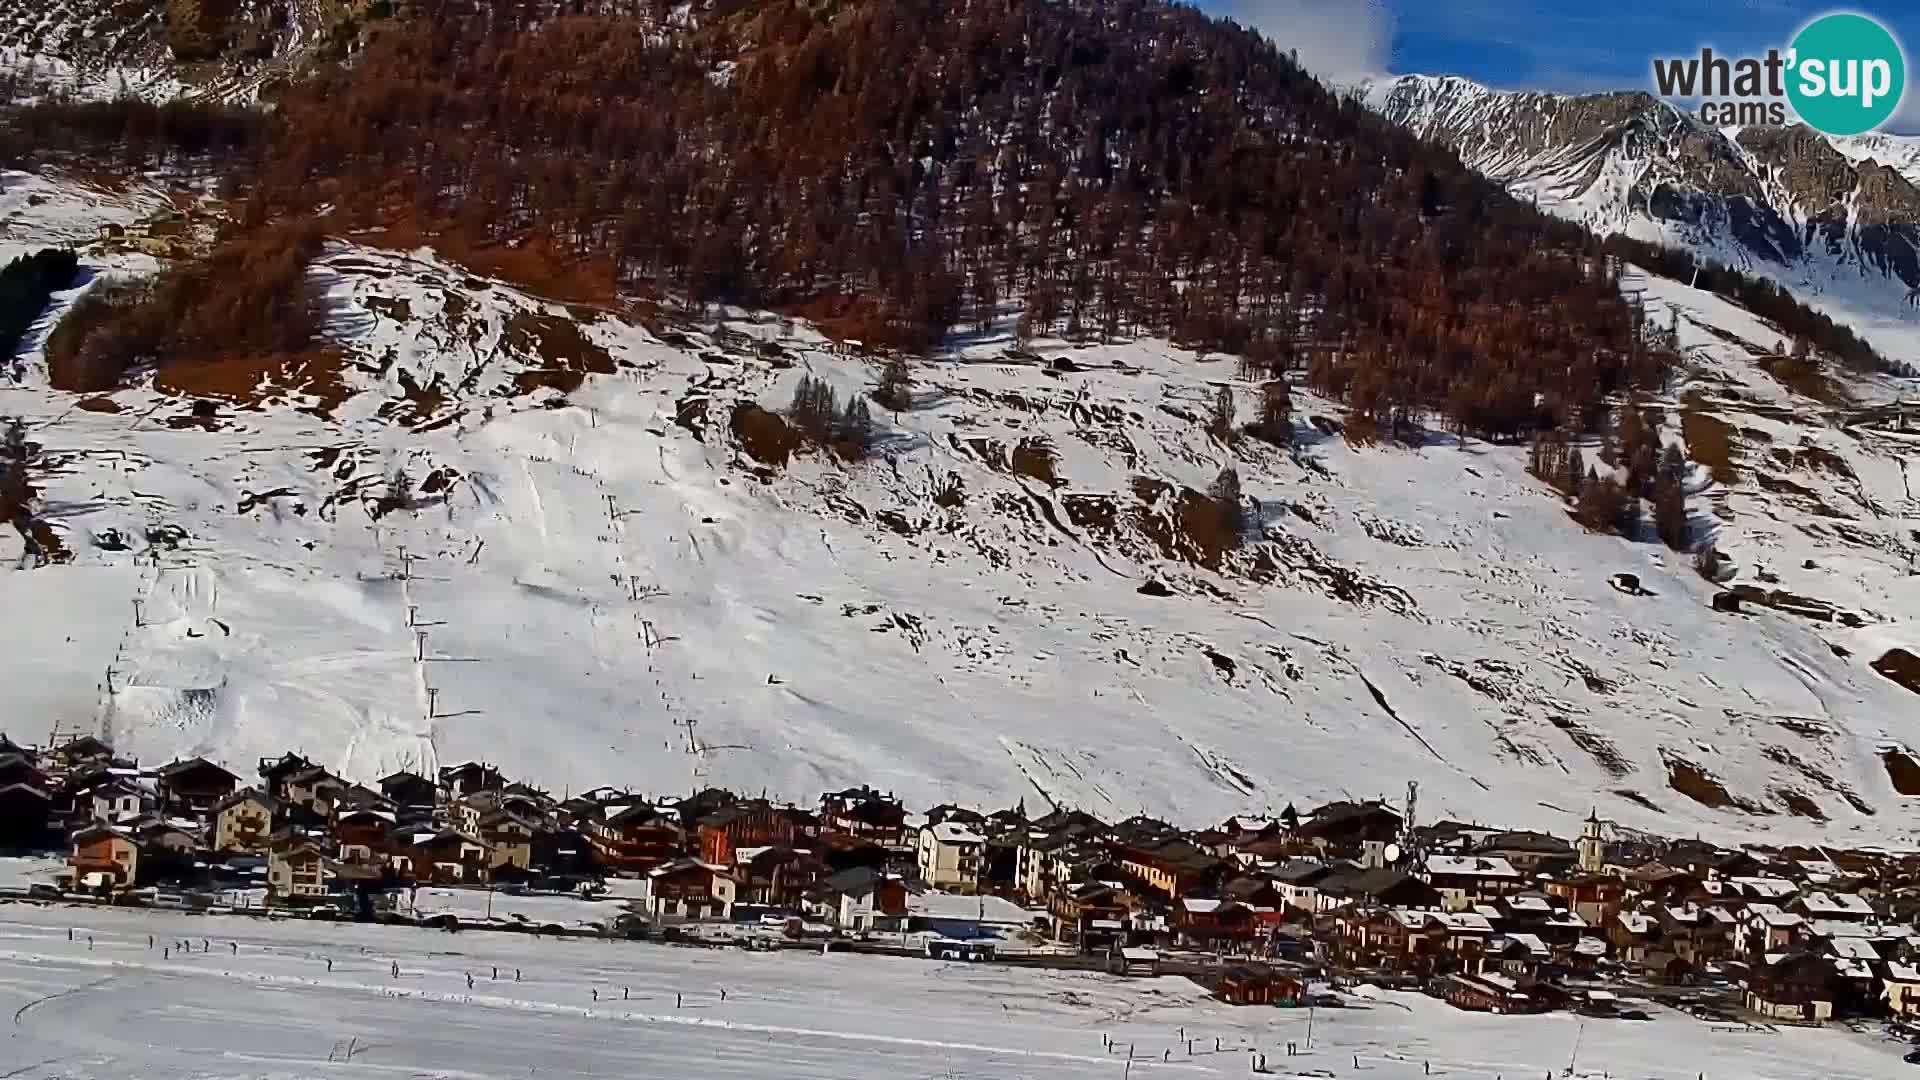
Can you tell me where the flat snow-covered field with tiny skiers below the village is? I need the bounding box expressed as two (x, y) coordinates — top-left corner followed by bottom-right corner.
(0, 905), (1910, 1080)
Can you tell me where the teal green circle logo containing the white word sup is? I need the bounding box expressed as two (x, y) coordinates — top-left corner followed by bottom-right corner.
(1788, 13), (1907, 135)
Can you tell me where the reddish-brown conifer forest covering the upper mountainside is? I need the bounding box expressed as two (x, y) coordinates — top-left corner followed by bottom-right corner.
(0, 0), (1874, 438)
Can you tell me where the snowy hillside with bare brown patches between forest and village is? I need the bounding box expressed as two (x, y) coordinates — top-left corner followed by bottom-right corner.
(11, 177), (1920, 842)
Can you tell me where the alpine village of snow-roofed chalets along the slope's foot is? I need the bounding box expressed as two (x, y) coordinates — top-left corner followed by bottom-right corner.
(0, 736), (1920, 1024)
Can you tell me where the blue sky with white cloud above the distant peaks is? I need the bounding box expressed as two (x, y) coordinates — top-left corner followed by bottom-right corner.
(1200, 0), (1920, 133)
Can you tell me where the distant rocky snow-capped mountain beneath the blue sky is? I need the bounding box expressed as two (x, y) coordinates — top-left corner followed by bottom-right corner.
(1357, 75), (1920, 363)
